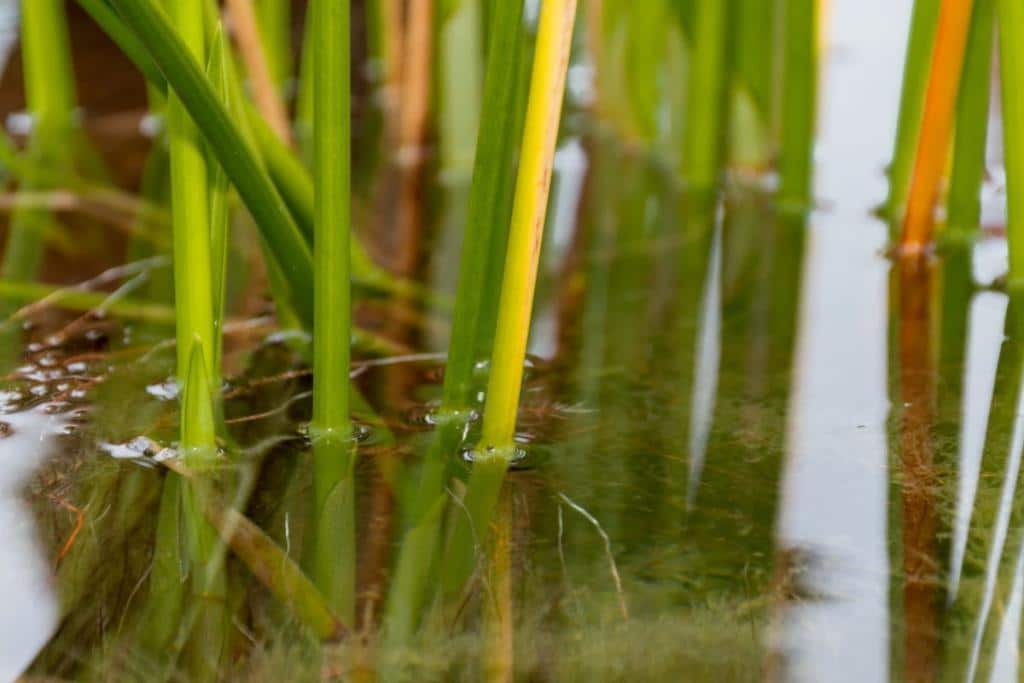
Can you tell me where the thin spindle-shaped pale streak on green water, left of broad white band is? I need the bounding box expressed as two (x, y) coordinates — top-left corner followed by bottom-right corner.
(686, 215), (722, 508)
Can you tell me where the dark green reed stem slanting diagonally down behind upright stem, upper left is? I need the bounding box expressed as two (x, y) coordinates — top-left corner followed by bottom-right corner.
(110, 0), (313, 328)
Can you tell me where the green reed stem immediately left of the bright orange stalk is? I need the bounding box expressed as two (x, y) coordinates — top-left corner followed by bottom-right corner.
(886, 0), (939, 220)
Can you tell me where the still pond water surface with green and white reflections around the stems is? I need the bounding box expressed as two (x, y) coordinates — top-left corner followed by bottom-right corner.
(0, 0), (1024, 682)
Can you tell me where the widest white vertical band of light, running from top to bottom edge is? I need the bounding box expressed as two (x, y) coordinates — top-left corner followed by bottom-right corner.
(773, 0), (911, 683)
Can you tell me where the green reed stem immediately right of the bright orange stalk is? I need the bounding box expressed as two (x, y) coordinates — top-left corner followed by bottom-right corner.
(943, 0), (995, 242)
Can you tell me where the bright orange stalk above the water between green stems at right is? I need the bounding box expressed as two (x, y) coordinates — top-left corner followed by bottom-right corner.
(900, 0), (974, 253)
